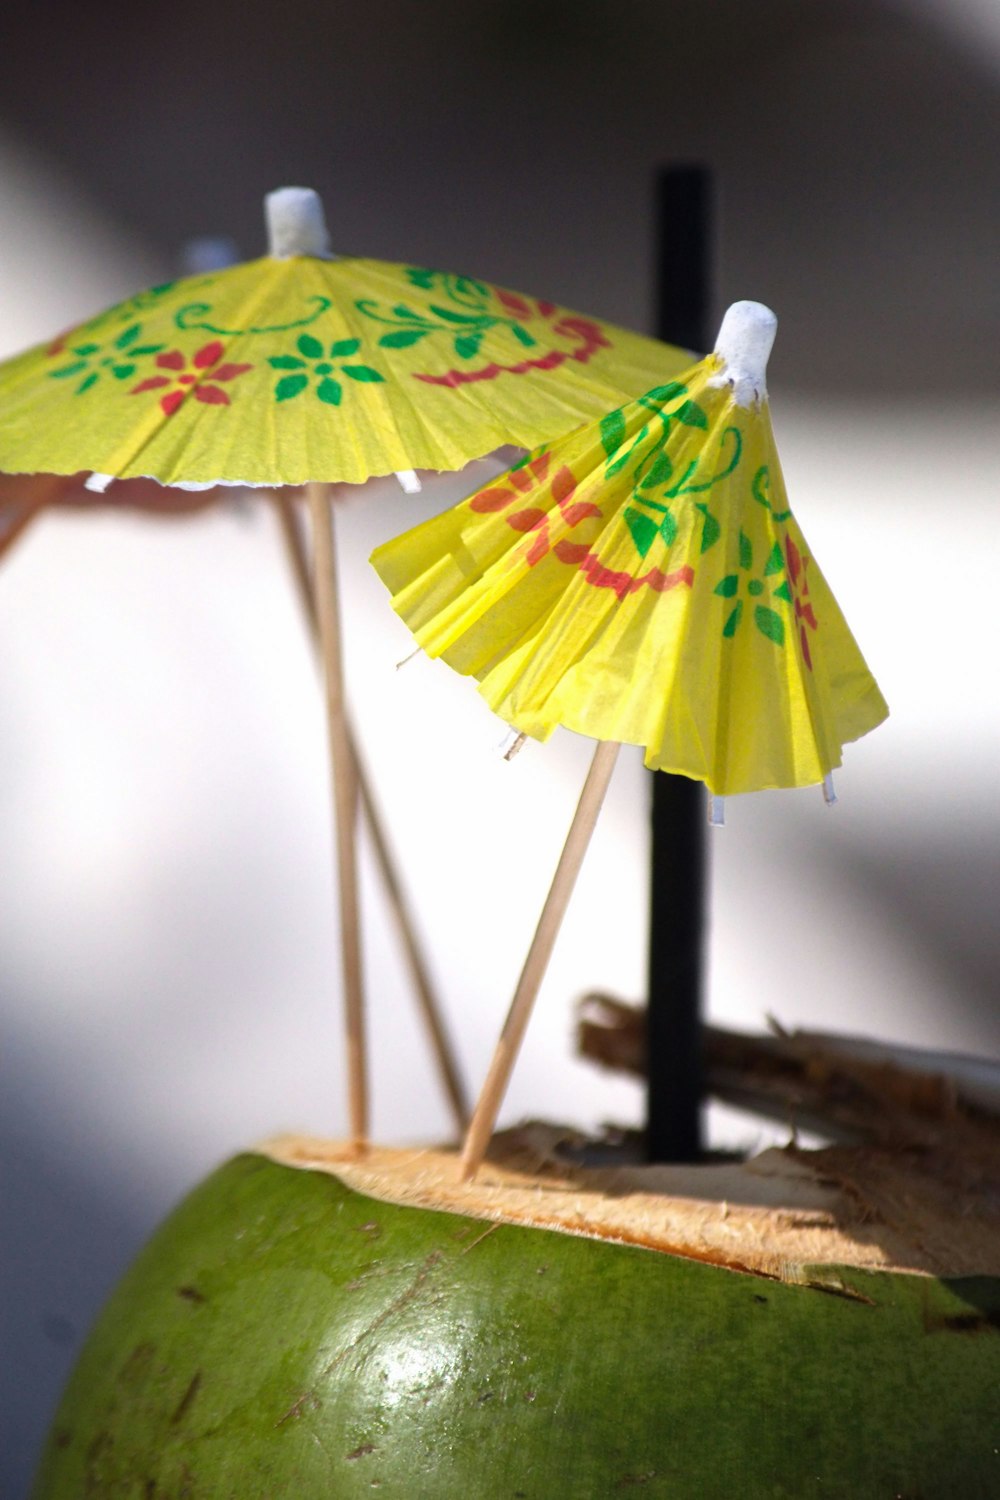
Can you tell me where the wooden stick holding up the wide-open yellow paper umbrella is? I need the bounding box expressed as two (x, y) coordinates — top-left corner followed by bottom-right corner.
(307, 485), (367, 1151)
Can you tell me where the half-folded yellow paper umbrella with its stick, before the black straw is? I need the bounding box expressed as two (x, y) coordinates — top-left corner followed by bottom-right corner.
(372, 303), (888, 1173)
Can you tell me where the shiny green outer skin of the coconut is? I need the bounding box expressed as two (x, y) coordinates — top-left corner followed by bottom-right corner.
(34, 1155), (1000, 1500)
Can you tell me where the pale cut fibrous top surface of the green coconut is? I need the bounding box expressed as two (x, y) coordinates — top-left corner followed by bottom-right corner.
(256, 1124), (1000, 1278)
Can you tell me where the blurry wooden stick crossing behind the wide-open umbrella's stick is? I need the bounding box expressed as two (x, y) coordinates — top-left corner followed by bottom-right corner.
(274, 491), (469, 1134)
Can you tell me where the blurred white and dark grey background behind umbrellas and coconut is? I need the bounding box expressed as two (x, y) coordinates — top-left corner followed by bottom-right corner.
(0, 0), (1000, 1500)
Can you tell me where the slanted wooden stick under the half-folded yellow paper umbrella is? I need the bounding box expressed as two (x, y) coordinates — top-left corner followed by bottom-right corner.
(460, 740), (621, 1182)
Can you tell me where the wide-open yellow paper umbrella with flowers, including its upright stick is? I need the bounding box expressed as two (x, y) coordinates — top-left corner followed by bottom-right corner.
(0, 189), (695, 1142)
